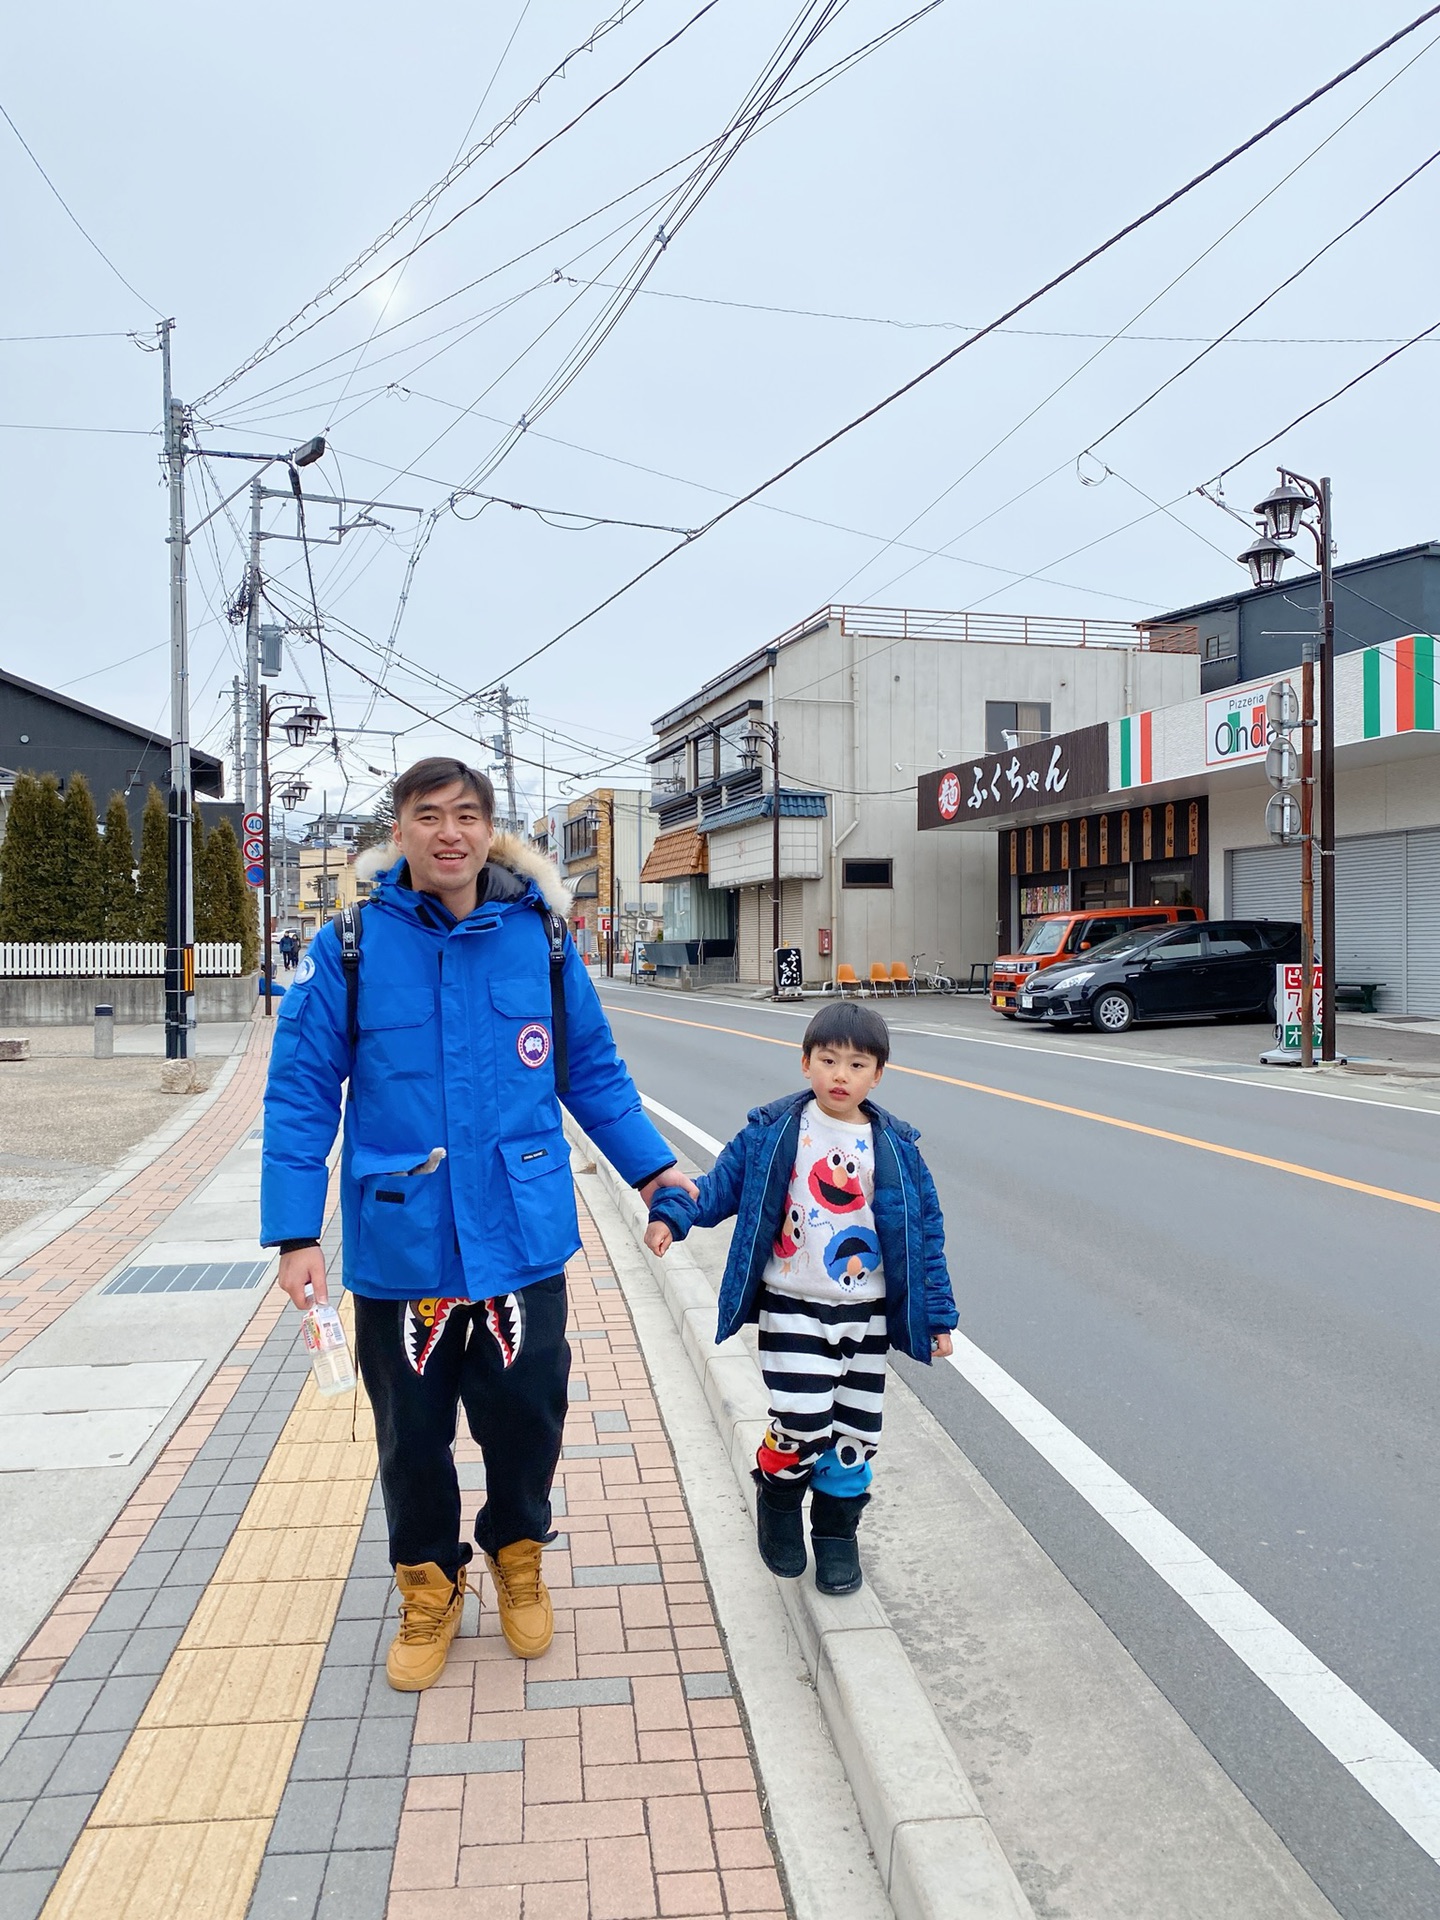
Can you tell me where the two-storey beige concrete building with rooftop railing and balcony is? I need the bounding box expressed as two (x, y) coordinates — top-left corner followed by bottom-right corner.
(645, 607), (1198, 983)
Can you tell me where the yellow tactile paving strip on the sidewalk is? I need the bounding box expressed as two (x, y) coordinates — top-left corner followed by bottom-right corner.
(42, 1300), (374, 1920)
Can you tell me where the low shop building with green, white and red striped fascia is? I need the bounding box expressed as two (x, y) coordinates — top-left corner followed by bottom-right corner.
(920, 634), (1440, 1016)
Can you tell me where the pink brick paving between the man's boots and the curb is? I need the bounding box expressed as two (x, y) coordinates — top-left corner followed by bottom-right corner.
(388, 1212), (785, 1920)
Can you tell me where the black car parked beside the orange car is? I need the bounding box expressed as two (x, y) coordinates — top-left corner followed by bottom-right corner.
(1016, 920), (1300, 1033)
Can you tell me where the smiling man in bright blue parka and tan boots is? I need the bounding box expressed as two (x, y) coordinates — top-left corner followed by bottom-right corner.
(261, 758), (695, 1692)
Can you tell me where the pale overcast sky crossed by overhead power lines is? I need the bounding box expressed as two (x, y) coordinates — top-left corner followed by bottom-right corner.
(0, 0), (1440, 825)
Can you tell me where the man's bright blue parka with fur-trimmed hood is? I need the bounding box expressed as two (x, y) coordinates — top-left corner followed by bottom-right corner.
(261, 843), (676, 1300)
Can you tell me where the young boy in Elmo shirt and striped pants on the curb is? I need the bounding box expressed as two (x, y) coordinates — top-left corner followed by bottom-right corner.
(645, 1000), (958, 1594)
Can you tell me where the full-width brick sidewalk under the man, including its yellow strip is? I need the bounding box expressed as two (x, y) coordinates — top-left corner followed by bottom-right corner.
(0, 1182), (785, 1920)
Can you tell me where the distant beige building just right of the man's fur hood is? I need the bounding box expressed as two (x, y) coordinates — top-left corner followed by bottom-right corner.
(534, 787), (662, 966)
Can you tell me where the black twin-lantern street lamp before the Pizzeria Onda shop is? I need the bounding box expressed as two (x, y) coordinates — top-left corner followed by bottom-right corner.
(1240, 467), (1334, 1060)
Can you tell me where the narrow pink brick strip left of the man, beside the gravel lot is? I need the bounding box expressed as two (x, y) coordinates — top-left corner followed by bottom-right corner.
(0, 1020), (275, 1365)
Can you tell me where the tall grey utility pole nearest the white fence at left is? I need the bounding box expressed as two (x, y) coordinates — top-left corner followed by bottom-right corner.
(156, 321), (196, 1060)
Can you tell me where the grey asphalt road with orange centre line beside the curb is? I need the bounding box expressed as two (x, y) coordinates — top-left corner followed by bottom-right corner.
(605, 985), (1440, 1920)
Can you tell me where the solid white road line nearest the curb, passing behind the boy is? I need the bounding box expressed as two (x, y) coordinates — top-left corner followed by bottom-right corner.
(639, 1094), (1440, 1860)
